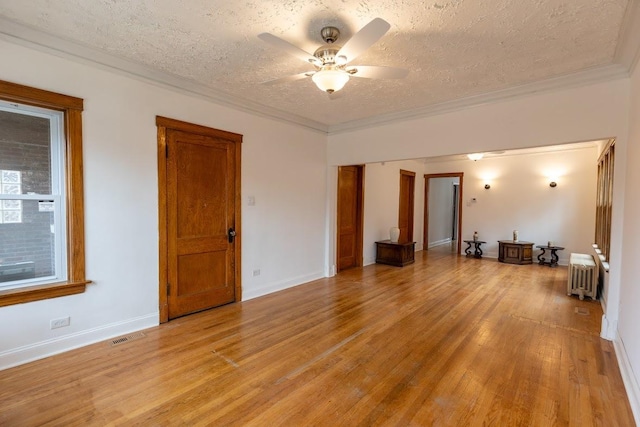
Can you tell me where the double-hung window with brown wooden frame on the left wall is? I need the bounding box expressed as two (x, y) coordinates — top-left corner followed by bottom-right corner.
(0, 81), (89, 306)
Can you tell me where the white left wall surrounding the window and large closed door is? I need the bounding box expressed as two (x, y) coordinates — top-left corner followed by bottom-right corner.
(0, 41), (327, 369)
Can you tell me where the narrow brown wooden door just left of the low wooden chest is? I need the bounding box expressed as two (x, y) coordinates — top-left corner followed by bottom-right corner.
(336, 165), (364, 272)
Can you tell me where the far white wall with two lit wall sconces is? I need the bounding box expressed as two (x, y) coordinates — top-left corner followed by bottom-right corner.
(426, 150), (598, 264)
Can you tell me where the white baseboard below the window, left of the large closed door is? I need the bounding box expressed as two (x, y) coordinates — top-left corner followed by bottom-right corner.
(0, 312), (159, 371)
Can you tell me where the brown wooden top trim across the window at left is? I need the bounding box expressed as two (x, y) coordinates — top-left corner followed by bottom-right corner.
(0, 80), (84, 111)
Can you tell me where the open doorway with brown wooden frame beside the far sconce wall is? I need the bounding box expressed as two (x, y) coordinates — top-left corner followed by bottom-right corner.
(423, 172), (464, 254)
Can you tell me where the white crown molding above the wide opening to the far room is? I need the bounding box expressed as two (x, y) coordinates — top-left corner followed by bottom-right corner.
(329, 64), (629, 135)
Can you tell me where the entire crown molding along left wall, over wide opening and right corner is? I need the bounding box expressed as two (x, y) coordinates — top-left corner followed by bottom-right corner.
(0, 15), (640, 135)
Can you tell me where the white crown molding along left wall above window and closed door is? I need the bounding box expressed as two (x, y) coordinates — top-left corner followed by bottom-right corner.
(0, 17), (328, 134)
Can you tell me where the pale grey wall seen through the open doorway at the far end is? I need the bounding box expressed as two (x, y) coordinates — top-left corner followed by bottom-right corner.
(426, 176), (460, 248)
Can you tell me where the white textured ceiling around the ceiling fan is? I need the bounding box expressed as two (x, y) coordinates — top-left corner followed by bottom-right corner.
(0, 0), (640, 132)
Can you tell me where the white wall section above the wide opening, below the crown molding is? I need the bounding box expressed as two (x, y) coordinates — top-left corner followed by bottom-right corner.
(328, 79), (629, 165)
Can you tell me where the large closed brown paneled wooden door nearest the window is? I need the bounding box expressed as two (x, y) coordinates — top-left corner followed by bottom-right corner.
(158, 118), (241, 320)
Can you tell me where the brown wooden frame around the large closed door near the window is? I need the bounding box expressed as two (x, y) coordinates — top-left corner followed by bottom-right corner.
(156, 116), (242, 323)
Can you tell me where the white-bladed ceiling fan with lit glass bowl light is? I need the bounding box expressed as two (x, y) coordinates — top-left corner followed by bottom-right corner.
(258, 18), (409, 94)
